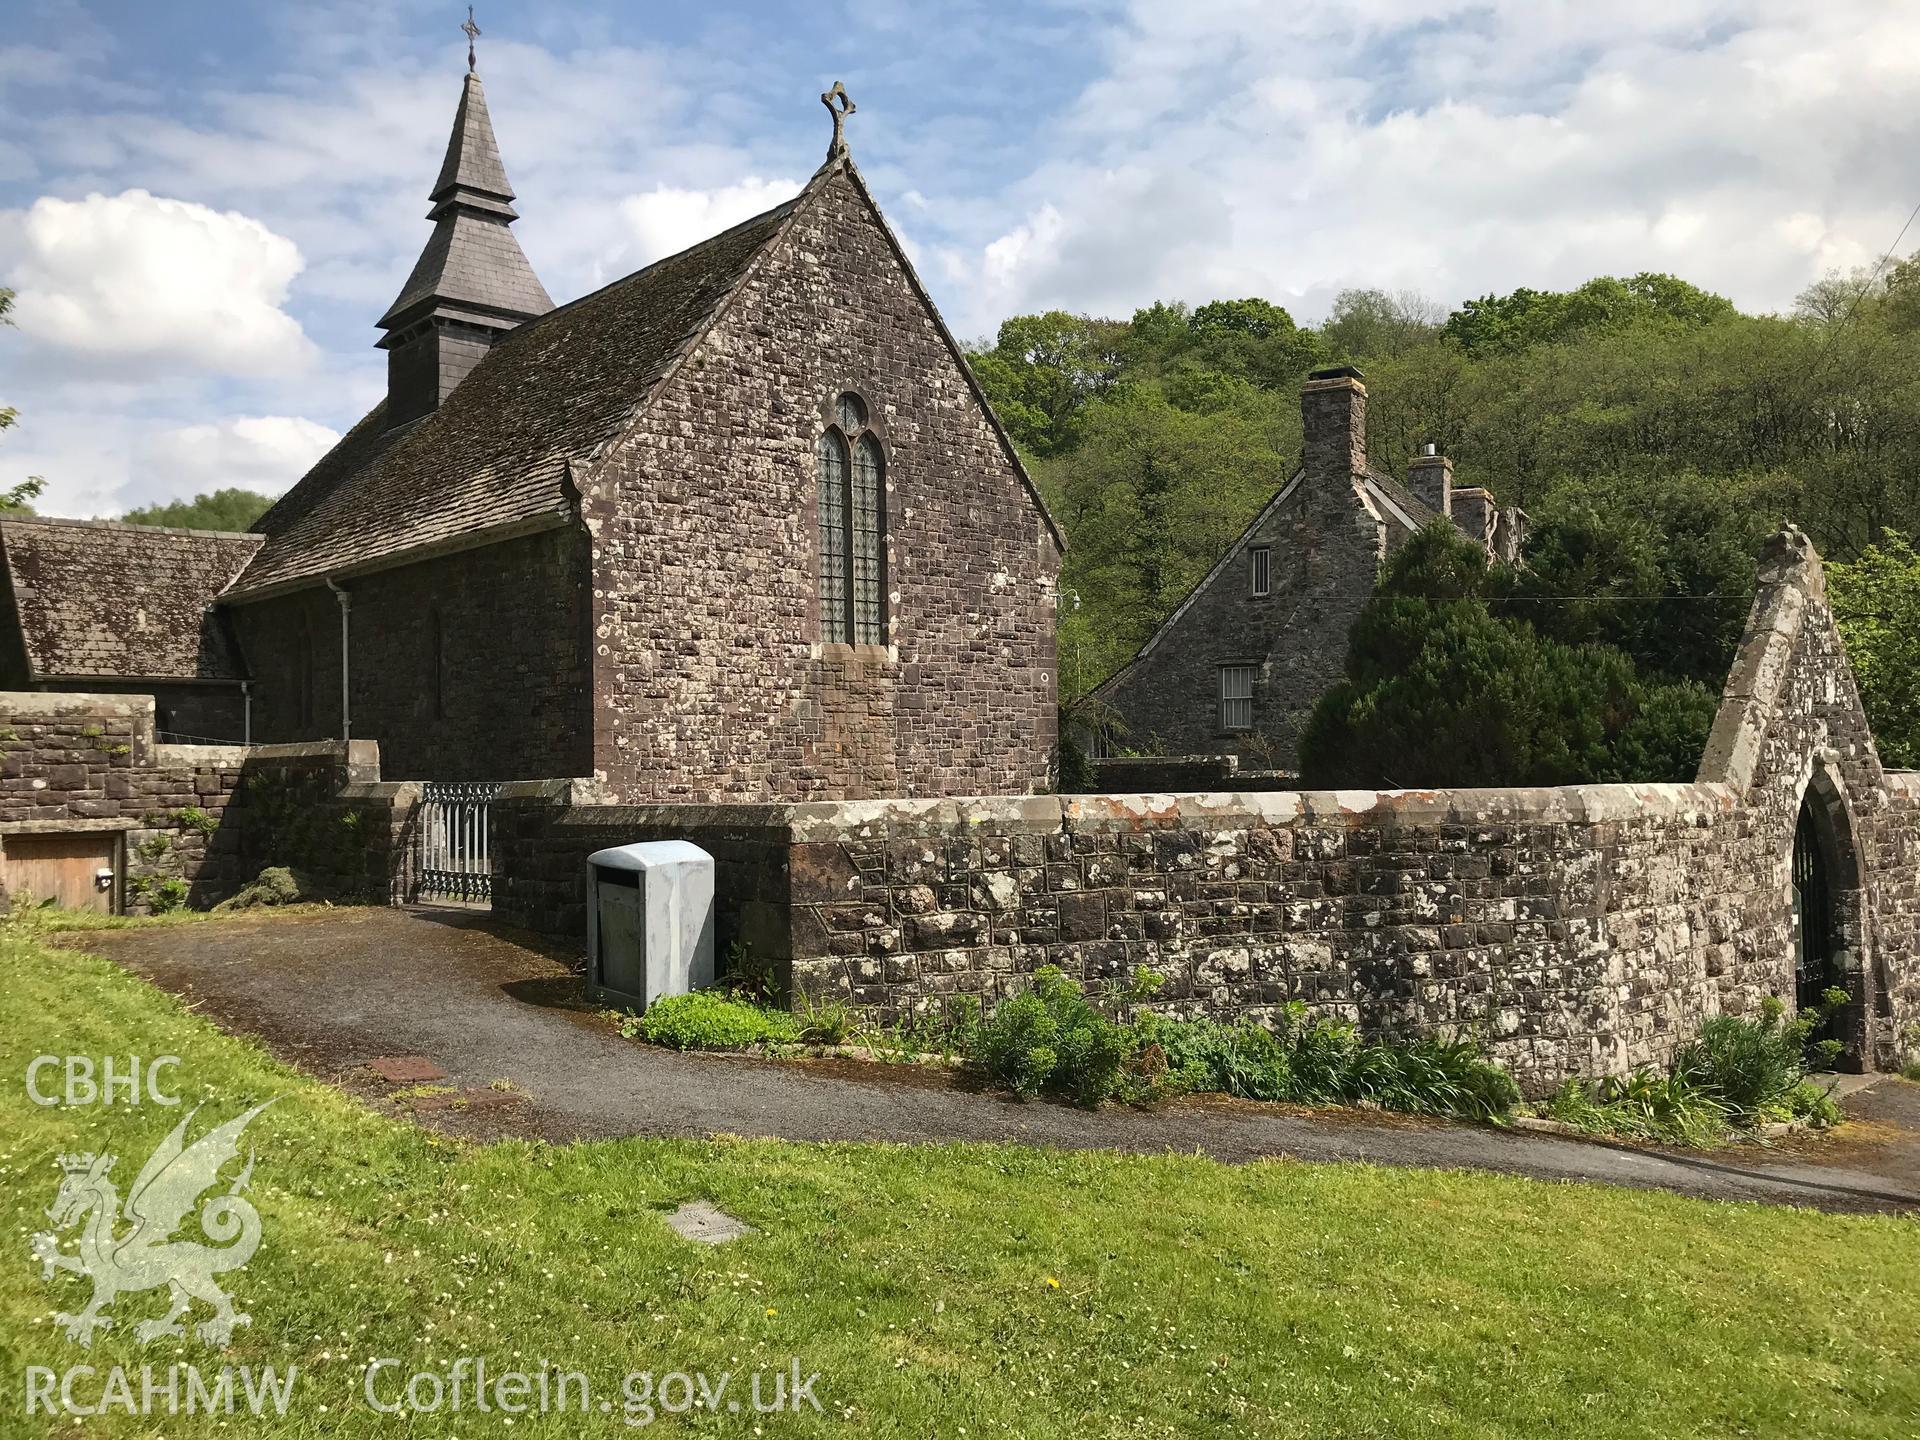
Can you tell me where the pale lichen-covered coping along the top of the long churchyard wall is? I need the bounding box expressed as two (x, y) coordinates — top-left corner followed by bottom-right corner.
(501, 776), (1751, 843)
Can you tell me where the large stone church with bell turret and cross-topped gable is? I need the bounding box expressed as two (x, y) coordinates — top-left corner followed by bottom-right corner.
(6, 71), (1062, 801)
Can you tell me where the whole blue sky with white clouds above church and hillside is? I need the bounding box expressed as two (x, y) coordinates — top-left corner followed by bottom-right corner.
(0, 0), (1920, 515)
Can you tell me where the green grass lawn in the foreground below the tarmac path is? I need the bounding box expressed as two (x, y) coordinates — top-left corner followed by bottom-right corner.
(0, 931), (1920, 1440)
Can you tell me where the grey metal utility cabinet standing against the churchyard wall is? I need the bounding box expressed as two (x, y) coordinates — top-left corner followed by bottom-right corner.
(588, 841), (714, 1010)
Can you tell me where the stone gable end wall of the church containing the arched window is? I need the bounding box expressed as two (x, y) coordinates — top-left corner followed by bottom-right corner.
(580, 159), (1060, 801)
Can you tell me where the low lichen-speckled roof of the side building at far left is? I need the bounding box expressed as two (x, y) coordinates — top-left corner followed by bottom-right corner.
(0, 516), (261, 682)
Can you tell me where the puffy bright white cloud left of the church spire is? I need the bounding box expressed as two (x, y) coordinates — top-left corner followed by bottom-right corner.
(8, 190), (313, 374)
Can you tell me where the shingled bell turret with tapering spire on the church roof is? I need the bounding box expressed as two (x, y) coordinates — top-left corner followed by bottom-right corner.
(380, 52), (553, 426)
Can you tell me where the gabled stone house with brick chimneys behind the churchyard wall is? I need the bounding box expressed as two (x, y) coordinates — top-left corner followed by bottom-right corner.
(1094, 365), (1524, 770)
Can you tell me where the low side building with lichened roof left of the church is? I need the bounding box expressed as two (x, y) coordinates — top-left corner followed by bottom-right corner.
(0, 515), (261, 743)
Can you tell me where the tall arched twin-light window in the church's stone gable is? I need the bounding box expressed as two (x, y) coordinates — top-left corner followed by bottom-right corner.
(816, 390), (887, 645)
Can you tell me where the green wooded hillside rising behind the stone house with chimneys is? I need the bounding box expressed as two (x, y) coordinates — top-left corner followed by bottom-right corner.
(972, 257), (1920, 760)
